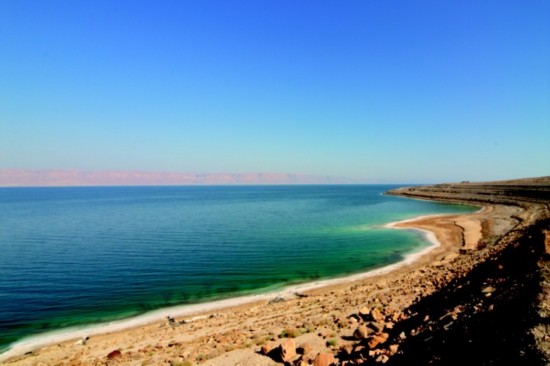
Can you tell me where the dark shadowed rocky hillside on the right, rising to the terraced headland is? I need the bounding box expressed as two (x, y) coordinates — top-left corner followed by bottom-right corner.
(387, 177), (550, 365)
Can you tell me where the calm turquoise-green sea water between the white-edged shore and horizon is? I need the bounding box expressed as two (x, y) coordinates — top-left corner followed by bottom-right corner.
(0, 185), (475, 349)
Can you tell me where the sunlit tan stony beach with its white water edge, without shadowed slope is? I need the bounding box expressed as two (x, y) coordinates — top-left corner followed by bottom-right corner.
(0, 179), (550, 365)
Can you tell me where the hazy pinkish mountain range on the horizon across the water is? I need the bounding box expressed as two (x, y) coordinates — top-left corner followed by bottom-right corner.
(0, 169), (360, 187)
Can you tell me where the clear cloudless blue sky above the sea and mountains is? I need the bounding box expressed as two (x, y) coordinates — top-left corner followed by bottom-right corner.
(0, 0), (550, 182)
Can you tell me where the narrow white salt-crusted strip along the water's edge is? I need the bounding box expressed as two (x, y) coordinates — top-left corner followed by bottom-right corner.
(0, 213), (452, 362)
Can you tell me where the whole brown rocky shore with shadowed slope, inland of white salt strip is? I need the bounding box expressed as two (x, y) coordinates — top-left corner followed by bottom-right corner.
(4, 177), (550, 366)
